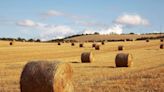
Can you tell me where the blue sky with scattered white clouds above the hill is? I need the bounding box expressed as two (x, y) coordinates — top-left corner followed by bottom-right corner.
(0, 0), (164, 40)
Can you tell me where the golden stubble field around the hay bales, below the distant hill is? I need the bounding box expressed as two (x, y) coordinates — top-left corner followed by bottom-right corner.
(0, 40), (164, 92)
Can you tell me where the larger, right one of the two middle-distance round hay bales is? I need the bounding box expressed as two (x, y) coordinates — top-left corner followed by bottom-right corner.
(115, 53), (133, 67)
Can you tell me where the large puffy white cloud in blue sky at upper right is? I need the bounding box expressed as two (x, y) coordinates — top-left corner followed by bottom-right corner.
(114, 14), (149, 26)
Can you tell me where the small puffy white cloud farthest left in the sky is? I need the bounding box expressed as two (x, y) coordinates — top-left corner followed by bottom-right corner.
(16, 19), (36, 27)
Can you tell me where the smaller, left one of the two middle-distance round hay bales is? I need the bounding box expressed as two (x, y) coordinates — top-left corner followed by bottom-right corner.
(81, 52), (94, 63)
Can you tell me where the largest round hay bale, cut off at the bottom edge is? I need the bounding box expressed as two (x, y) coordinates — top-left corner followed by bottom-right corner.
(20, 61), (73, 92)
